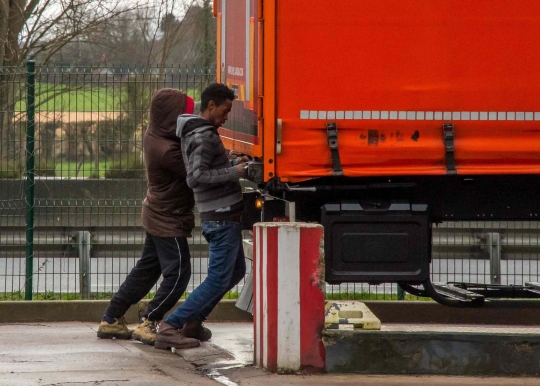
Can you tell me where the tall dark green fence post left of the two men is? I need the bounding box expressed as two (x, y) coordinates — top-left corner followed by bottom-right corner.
(24, 60), (36, 300)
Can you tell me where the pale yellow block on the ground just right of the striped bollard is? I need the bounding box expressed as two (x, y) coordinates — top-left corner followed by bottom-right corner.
(324, 301), (381, 330)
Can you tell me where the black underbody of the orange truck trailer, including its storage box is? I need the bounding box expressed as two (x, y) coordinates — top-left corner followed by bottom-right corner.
(251, 175), (540, 307)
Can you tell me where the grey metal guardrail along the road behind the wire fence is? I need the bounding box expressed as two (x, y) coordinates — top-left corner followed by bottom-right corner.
(4, 211), (540, 299)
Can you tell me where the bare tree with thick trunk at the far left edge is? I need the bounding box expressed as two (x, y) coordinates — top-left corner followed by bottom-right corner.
(0, 0), (147, 161)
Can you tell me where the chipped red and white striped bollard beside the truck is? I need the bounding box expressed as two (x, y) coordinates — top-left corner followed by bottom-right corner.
(253, 222), (326, 372)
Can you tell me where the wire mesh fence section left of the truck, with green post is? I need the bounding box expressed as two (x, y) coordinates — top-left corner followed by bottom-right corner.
(0, 62), (219, 300)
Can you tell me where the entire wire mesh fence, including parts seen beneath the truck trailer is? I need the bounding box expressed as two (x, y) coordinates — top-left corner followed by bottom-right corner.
(0, 65), (540, 300)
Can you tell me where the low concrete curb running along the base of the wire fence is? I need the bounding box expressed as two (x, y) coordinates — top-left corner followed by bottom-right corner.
(0, 300), (540, 326)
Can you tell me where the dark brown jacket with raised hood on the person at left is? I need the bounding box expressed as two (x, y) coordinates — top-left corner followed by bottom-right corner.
(142, 88), (195, 237)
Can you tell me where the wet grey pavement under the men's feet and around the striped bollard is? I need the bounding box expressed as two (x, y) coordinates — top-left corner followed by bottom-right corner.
(0, 322), (540, 386)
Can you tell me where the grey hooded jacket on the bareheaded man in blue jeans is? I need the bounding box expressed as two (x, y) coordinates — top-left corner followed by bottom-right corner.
(176, 114), (243, 221)
